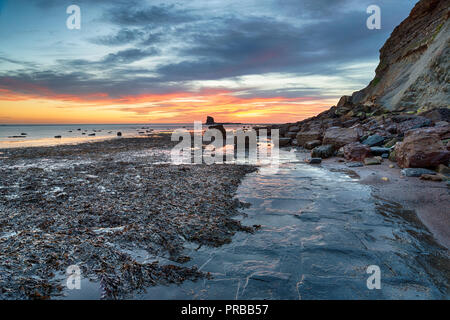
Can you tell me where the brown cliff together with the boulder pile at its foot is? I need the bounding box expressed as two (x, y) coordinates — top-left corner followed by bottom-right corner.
(260, 0), (450, 179)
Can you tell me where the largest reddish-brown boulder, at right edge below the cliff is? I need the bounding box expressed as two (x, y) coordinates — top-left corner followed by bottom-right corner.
(395, 130), (450, 168)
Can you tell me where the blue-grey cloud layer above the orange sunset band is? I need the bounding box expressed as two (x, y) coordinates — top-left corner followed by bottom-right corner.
(0, 0), (412, 120)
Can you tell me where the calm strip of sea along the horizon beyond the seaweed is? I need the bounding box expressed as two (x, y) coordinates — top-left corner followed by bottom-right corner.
(0, 122), (251, 149)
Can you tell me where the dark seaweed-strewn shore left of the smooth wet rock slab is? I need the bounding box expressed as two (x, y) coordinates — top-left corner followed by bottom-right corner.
(0, 134), (254, 299)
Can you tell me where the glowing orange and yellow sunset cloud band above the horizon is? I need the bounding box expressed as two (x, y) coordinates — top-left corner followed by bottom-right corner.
(0, 83), (335, 123)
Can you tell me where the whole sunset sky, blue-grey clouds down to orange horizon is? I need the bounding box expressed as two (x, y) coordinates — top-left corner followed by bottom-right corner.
(0, 0), (417, 124)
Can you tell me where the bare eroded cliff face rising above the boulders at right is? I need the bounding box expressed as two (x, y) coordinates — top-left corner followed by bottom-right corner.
(352, 0), (450, 111)
